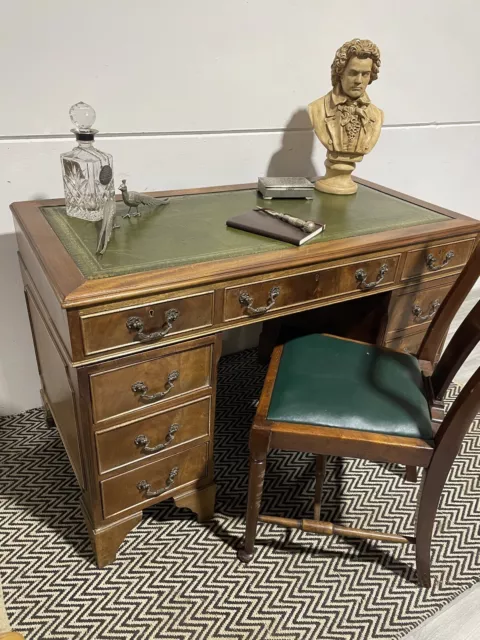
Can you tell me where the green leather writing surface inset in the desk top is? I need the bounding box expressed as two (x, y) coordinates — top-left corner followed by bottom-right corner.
(42, 185), (448, 279)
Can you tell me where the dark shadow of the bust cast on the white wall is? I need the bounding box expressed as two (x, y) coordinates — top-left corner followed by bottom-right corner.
(267, 109), (318, 178)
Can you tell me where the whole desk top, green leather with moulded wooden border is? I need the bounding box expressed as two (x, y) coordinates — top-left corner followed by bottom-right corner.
(11, 177), (480, 308)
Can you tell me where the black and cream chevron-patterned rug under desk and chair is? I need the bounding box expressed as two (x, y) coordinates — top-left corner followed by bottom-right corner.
(0, 350), (480, 640)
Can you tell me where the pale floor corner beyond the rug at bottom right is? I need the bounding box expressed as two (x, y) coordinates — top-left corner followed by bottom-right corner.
(403, 583), (480, 640)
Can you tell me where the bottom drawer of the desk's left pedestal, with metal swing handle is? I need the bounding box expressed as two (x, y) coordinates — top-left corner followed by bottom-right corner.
(100, 443), (209, 518)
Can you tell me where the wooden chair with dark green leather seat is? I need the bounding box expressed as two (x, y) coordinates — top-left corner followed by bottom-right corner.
(238, 245), (480, 587)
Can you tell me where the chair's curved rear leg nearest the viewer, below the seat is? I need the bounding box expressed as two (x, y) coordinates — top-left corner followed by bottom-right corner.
(415, 470), (444, 587)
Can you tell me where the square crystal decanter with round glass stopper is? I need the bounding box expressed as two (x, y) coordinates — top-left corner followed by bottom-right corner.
(60, 102), (115, 222)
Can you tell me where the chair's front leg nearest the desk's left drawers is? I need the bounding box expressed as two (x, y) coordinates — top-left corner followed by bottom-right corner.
(237, 429), (268, 563)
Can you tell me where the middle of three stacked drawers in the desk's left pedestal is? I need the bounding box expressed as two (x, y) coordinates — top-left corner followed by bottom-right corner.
(95, 398), (211, 473)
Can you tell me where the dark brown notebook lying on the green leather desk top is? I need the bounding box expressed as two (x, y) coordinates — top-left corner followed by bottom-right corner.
(227, 211), (325, 246)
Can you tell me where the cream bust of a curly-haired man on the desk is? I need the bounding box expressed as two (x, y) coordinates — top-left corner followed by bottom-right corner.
(308, 38), (383, 195)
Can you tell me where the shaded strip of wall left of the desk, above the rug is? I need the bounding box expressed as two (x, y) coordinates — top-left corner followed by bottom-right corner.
(0, 233), (41, 415)
